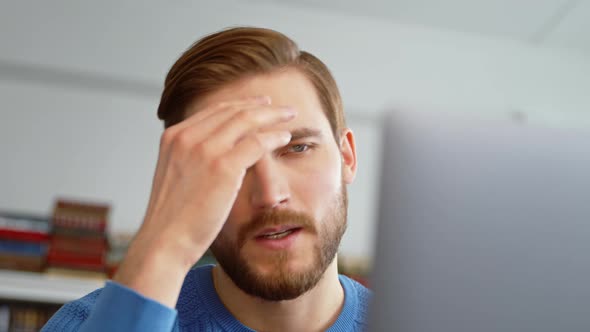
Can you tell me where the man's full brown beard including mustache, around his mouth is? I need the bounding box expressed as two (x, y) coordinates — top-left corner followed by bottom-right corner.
(211, 184), (348, 301)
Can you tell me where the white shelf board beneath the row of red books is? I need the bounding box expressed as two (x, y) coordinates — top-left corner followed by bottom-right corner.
(0, 270), (104, 304)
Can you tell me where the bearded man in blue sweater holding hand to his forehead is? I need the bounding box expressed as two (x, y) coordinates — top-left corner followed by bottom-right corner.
(44, 28), (370, 332)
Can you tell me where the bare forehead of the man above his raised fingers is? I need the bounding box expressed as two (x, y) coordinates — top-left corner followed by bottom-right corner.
(189, 68), (331, 136)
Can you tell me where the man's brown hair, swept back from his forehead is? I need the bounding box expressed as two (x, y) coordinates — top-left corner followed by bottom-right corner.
(158, 27), (346, 141)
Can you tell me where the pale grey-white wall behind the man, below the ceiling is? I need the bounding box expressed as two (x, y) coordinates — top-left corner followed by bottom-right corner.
(0, 0), (590, 256)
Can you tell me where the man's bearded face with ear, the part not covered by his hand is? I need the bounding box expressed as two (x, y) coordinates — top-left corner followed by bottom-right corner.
(194, 69), (356, 301)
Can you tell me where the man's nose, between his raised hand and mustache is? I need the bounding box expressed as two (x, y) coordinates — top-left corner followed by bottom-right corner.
(245, 156), (290, 210)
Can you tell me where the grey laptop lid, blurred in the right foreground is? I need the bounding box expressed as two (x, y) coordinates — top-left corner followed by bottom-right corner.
(369, 111), (590, 332)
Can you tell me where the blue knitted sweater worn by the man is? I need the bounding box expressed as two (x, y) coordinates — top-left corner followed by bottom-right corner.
(41, 265), (371, 332)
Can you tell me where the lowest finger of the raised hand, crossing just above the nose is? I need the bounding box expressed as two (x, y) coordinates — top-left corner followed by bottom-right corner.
(226, 130), (291, 170)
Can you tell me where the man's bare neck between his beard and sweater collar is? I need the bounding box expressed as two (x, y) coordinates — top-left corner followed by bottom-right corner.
(213, 258), (344, 332)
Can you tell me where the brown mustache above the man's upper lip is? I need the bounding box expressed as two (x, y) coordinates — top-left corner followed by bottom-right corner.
(238, 209), (317, 248)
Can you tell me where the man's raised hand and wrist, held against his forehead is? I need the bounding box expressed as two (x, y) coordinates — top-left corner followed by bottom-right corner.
(114, 97), (295, 307)
